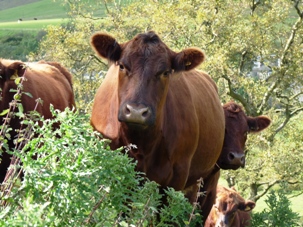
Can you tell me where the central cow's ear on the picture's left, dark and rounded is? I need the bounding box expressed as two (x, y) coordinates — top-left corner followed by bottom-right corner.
(91, 33), (122, 62)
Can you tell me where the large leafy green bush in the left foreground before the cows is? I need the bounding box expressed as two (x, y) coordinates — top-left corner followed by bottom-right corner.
(0, 110), (202, 227)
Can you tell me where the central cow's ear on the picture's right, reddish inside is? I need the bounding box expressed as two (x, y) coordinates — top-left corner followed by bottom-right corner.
(173, 48), (205, 72)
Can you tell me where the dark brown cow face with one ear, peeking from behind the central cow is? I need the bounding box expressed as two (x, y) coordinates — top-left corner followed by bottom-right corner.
(217, 102), (271, 170)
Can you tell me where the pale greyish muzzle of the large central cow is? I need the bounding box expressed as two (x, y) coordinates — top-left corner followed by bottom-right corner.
(118, 103), (153, 127)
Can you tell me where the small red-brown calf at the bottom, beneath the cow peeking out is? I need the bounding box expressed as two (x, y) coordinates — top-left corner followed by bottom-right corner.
(205, 185), (256, 227)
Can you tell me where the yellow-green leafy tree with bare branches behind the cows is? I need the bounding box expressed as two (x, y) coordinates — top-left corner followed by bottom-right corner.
(33, 0), (303, 200)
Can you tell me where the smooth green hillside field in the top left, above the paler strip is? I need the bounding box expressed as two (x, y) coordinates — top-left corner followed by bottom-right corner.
(0, 0), (67, 23)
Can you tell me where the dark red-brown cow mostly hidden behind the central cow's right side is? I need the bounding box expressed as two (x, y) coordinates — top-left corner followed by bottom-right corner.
(192, 102), (271, 225)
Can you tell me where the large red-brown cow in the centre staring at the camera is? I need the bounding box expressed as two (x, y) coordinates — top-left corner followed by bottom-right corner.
(91, 31), (225, 219)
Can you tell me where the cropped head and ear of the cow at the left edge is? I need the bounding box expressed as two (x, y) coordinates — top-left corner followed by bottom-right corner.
(0, 59), (25, 89)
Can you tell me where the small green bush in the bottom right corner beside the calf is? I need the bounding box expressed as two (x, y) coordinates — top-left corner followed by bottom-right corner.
(252, 189), (302, 227)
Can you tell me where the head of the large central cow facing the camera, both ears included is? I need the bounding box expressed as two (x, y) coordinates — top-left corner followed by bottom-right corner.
(91, 31), (204, 129)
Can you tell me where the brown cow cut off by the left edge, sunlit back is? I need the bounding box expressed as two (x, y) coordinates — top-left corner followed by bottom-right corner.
(0, 59), (75, 182)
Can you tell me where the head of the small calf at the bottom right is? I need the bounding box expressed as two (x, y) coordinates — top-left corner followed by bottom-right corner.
(212, 186), (256, 227)
